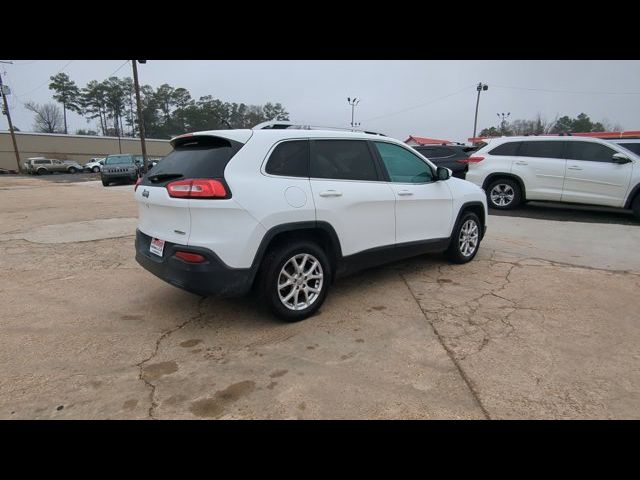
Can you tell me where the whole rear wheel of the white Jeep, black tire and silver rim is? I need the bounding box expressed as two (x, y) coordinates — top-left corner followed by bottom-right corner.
(261, 240), (332, 322)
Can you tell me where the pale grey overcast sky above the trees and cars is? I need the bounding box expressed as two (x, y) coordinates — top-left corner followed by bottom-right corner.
(0, 59), (640, 141)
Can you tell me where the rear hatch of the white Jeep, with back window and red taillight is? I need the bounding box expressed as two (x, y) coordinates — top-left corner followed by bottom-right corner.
(135, 131), (251, 245)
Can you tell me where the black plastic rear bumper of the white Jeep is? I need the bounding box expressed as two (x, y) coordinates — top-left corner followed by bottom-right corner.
(136, 230), (255, 297)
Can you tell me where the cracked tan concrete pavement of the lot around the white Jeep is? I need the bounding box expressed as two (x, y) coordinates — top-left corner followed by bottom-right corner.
(0, 176), (640, 418)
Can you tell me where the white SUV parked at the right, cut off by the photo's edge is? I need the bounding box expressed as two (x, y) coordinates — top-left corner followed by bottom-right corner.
(466, 136), (640, 218)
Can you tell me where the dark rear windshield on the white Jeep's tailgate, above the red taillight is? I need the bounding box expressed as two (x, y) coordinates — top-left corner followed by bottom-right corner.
(141, 136), (244, 185)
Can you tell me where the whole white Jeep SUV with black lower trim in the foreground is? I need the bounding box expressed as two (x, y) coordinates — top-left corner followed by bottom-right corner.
(135, 128), (487, 321)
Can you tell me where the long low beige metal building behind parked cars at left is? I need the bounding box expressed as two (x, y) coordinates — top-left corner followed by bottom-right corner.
(0, 130), (171, 170)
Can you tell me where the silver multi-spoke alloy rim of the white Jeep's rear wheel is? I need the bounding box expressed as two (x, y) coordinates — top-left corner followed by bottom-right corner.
(278, 253), (324, 310)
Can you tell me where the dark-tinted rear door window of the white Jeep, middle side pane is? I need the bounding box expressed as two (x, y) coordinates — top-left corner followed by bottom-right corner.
(310, 140), (378, 180)
